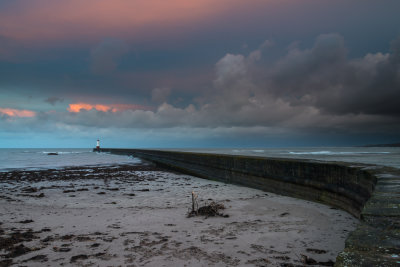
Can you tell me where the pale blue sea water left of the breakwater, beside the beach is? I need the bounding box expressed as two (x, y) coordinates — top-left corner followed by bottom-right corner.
(0, 148), (141, 171)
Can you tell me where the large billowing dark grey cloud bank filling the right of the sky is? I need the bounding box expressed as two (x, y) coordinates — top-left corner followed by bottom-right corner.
(84, 34), (400, 132)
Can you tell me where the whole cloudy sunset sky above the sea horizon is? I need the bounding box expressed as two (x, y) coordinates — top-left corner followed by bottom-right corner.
(0, 0), (400, 148)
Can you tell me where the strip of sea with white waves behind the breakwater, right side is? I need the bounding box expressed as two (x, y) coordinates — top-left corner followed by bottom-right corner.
(178, 147), (400, 168)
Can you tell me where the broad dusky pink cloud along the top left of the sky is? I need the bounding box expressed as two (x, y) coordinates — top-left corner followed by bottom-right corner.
(0, 0), (271, 41)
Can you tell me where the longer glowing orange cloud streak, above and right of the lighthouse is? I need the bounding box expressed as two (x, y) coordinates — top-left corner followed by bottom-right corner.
(67, 102), (151, 113)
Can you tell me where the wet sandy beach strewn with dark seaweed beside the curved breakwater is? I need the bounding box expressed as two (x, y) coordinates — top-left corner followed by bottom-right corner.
(0, 165), (358, 266)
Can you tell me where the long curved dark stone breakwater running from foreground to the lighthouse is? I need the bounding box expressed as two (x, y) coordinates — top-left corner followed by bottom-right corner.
(97, 149), (400, 266)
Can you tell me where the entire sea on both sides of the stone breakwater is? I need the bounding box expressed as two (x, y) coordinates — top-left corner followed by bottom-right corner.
(0, 147), (400, 172)
